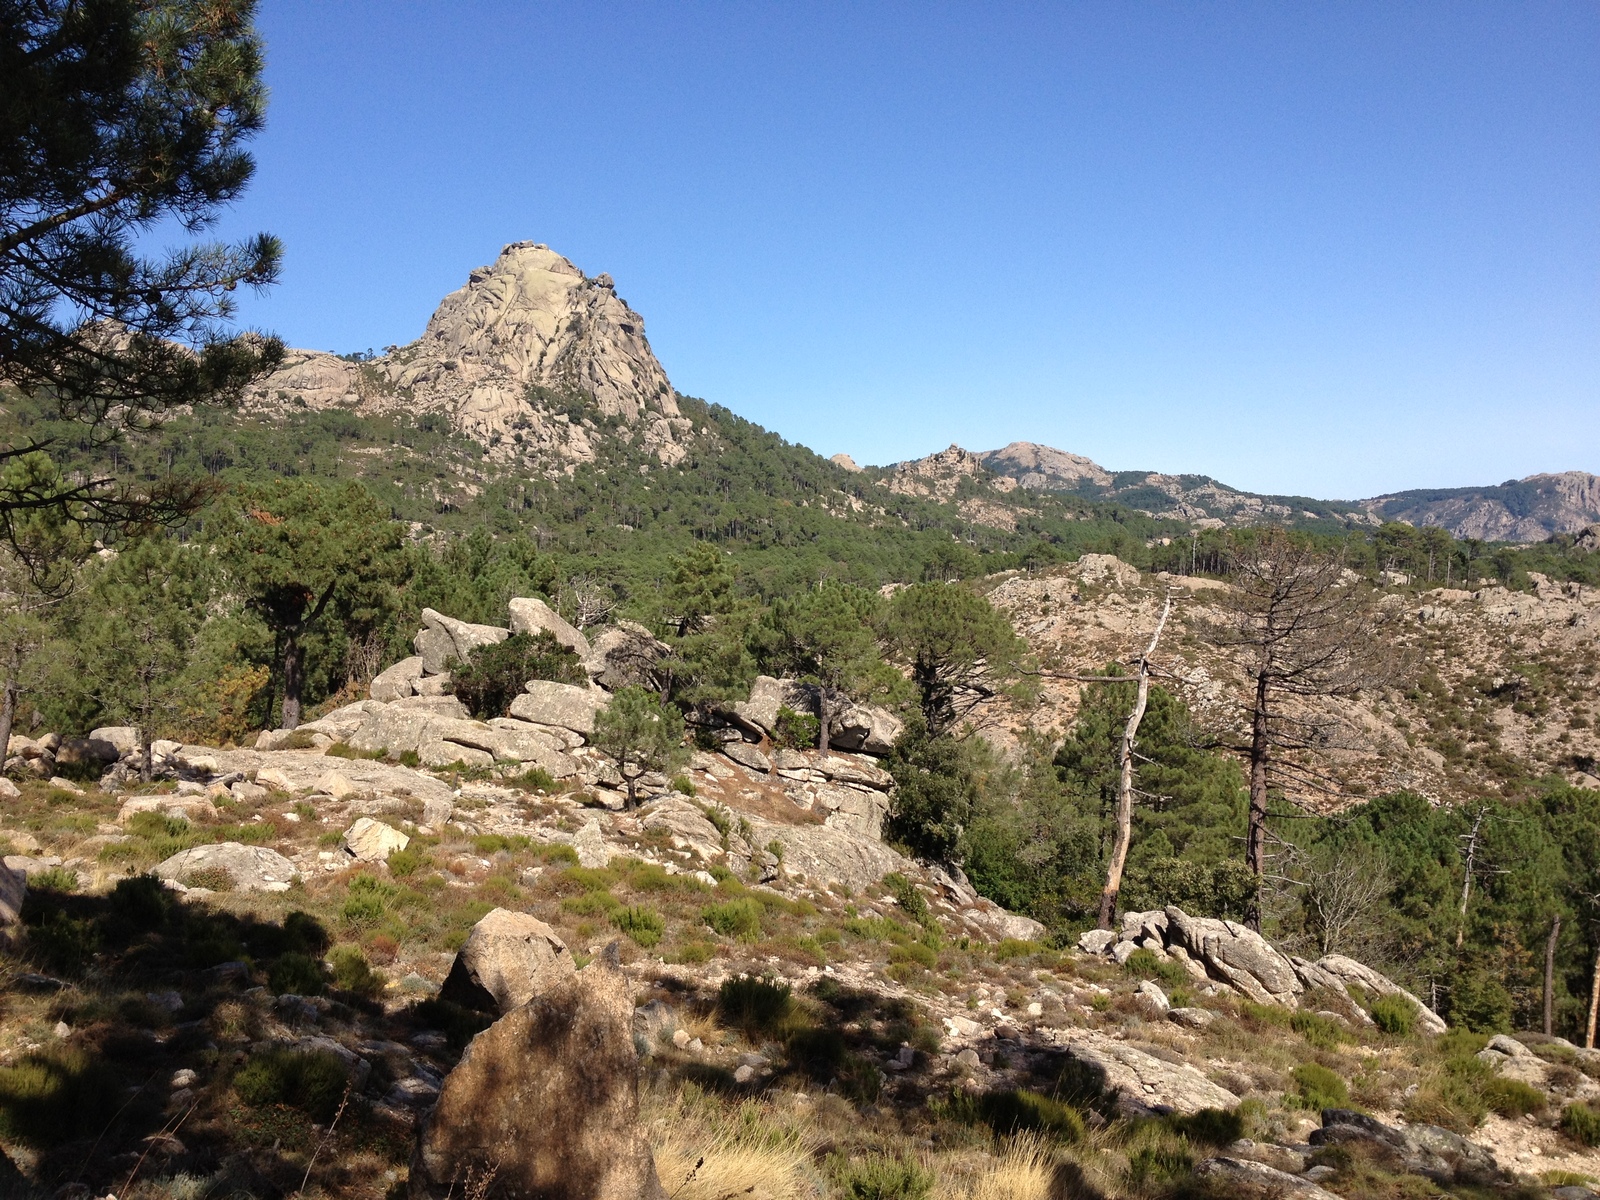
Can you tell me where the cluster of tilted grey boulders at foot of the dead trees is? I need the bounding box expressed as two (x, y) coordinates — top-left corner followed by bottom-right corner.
(1078, 906), (1445, 1034)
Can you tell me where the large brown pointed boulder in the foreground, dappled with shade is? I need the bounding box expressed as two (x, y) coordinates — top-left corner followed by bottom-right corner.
(410, 944), (667, 1200)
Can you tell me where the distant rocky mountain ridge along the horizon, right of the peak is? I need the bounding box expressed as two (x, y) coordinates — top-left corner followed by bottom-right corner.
(878, 442), (1600, 542)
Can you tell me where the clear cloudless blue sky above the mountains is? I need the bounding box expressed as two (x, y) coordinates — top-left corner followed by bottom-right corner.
(206, 0), (1600, 499)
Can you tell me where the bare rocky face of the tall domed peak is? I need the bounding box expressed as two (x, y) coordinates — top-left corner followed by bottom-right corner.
(246, 242), (693, 474)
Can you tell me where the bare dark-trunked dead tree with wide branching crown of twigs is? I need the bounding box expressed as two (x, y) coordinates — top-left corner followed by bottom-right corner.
(1205, 530), (1408, 928)
